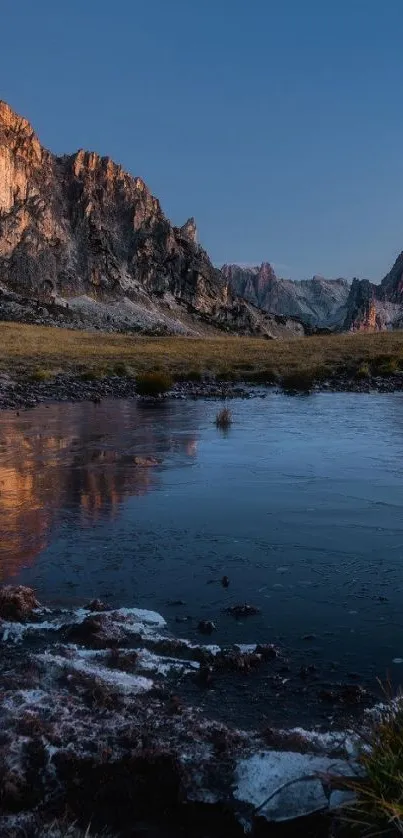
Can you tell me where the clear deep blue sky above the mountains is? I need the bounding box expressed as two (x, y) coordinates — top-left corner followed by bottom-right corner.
(0, 0), (403, 280)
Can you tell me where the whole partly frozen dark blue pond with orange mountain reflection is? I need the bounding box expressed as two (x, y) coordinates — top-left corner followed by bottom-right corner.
(0, 393), (403, 724)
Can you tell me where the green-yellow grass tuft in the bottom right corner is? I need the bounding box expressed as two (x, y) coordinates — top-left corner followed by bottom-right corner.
(345, 703), (403, 835)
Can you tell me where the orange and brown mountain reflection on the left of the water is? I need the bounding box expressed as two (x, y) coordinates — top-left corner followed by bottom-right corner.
(0, 402), (197, 581)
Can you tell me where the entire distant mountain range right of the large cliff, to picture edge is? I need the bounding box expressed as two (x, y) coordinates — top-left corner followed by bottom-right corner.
(226, 253), (403, 332)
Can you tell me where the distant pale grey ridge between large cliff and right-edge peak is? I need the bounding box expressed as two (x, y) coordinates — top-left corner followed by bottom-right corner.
(222, 262), (350, 329)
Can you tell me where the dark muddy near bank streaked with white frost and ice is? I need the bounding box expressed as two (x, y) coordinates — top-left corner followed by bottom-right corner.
(0, 588), (366, 836)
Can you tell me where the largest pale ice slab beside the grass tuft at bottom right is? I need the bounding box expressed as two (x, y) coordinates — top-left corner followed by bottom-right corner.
(234, 751), (352, 821)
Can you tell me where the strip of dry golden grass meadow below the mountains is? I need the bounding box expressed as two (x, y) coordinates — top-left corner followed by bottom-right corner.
(0, 323), (403, 380)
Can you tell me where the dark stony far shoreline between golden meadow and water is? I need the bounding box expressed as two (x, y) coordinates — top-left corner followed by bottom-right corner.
(0, 372), (403, 410)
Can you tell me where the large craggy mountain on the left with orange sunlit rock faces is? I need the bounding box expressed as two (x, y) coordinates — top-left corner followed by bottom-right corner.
(0, 101), (304, 337)
